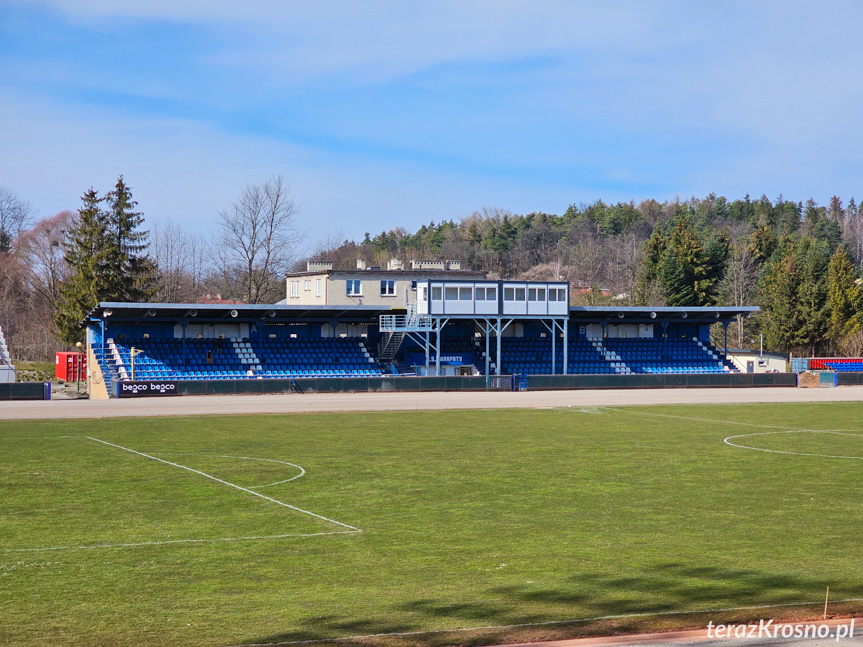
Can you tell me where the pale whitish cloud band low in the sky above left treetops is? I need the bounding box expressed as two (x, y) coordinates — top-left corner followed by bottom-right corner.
(0, 92), (598, 240)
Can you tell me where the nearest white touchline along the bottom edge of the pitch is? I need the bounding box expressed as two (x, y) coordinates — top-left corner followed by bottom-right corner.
(232, 598), (863, 647)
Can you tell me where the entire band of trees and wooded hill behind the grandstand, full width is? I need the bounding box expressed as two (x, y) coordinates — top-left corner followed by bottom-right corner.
(0, 176), (863, 359)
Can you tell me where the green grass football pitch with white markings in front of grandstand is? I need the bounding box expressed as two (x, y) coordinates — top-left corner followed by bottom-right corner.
(0, 404), (863, 646)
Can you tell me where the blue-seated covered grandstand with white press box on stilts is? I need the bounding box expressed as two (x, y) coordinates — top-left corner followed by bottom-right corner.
(83, 288), (755, 397)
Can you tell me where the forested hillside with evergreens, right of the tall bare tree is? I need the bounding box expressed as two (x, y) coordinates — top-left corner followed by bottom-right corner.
(311, 194), (863, 355)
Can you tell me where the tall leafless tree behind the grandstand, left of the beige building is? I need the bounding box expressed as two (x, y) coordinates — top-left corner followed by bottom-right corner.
(214, 175), (304, 303)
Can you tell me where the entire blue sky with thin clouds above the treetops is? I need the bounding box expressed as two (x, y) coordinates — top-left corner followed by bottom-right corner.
(0, 0), (863, 243)
